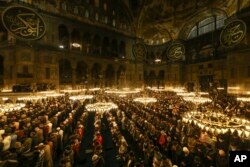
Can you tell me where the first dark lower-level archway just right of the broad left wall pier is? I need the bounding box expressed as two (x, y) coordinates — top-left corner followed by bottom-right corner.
(59, 59), (72, 84)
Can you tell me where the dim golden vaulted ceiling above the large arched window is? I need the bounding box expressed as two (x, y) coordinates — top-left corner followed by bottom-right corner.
(124, 0), (250, 45)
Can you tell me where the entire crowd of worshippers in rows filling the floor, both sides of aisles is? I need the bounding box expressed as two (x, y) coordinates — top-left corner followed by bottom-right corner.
(0, 91), (250, 167)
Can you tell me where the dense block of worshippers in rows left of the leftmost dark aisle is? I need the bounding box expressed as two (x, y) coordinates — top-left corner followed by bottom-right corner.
(0, 96), (87, 167)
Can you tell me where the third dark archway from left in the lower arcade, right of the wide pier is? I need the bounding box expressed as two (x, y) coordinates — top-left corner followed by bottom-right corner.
(91, 63), (103, 87)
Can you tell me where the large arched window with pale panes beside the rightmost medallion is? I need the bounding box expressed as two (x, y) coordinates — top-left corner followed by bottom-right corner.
(188, 15), (226, 39)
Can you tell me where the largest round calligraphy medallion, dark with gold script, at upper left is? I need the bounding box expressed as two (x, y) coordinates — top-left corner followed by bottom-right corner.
(2, 6), (46, 40)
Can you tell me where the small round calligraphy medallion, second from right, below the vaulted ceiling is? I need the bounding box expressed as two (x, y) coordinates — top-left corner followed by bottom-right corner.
(167, 43), (185, 61)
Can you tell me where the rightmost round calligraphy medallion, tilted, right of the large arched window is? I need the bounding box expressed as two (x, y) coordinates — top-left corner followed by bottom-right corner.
(220, 20), (246, 47)
